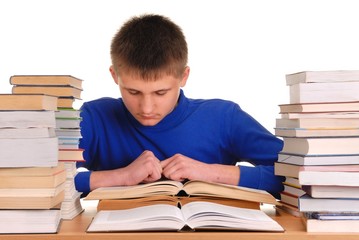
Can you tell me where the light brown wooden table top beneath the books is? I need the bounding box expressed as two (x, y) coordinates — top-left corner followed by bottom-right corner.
(0, 201), (359, 240)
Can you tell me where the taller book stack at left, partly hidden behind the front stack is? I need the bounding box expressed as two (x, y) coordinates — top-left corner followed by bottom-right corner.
(10, 75), (84, 219)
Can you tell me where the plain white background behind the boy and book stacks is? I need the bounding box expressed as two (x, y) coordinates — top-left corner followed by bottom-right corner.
(0, 0), (359, 131)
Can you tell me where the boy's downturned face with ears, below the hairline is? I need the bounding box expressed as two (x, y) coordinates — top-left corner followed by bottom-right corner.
(110, 67), (189, 126)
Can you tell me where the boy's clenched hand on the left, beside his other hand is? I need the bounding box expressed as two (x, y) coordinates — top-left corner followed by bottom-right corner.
(123, 150), (162, 185)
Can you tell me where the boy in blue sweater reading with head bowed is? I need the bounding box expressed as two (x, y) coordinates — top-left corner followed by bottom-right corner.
(75, 14), (283, 196)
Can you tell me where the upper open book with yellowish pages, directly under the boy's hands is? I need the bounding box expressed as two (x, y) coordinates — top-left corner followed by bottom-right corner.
(86, 180), (278, 210)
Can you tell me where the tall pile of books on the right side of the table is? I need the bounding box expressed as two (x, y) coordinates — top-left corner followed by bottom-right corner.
(275, 70), (359, 232)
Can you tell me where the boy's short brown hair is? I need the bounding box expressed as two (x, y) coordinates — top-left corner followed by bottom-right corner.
(111, 14), (188, 79)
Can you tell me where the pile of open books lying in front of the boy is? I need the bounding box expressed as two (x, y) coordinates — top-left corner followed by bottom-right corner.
(85, 180), (284, 232)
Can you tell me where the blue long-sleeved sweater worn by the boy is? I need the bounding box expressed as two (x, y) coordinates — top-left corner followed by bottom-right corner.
(75, 90), (283, 196)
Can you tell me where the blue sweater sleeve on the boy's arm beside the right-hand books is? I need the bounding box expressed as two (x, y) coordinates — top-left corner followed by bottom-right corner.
(227, 105), (284, 198)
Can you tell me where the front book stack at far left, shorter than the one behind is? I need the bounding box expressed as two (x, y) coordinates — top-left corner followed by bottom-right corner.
(0, 94), (66, 233)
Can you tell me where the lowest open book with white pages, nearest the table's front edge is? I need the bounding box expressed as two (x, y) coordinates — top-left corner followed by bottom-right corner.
(87, 201), (284, 232)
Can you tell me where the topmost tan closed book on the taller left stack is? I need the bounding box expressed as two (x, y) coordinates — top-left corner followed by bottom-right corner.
(10, 75), (83, 89)
